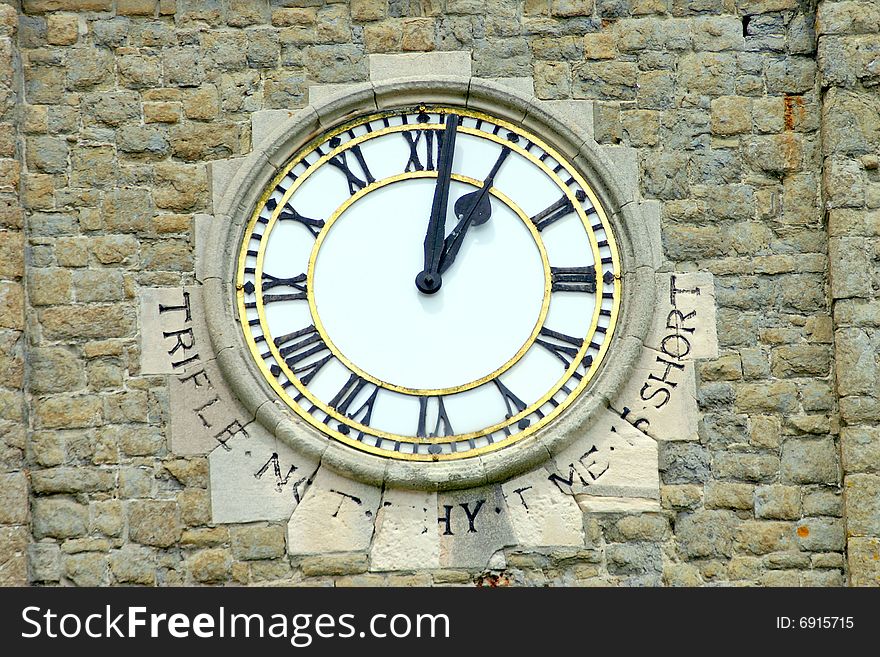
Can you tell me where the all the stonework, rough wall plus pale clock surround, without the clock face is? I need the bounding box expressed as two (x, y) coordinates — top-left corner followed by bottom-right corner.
(0, 0), (880, 586)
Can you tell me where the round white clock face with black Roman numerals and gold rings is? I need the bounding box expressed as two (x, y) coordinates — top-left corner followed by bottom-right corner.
(236, 106), (621, 461)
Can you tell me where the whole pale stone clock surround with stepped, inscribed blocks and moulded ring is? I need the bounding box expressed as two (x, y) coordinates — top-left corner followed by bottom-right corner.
(140, 53), (718, 570)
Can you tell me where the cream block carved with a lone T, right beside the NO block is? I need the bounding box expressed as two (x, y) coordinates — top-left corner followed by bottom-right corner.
(287, 467), (381, 554)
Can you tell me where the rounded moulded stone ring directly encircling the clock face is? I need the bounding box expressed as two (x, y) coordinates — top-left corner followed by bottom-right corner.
(202, 70), (659, 490)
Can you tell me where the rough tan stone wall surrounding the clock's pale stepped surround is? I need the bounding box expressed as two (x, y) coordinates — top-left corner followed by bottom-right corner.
(0, 0), (880, 586)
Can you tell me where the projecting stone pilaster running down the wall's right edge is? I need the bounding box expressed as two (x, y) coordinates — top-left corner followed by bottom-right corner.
(817, 2), (880, 586)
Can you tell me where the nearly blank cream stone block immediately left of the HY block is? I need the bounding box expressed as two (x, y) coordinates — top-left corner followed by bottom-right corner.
(370, 488), (440, 571)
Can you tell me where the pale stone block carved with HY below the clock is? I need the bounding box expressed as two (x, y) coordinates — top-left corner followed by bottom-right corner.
(437, 486), (516, 568)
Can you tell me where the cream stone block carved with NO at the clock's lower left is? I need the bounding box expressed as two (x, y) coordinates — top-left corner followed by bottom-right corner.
(208, 422), (319, 523)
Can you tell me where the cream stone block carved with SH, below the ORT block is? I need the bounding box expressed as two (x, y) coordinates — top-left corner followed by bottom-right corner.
(612, 347), (700, 440)
